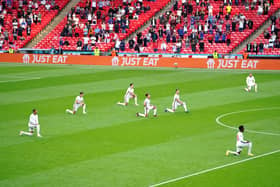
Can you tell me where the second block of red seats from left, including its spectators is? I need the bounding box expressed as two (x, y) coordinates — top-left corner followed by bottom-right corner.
(35, 0), (169, 51)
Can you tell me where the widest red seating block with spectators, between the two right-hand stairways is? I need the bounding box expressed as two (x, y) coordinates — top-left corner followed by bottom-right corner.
(121, 0), (280, 54)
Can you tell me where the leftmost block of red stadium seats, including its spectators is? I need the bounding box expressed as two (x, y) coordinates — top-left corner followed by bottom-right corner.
(0, 0), (69, 50)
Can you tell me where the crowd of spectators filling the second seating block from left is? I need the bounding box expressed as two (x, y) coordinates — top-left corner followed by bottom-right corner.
(56, 0), (154, 50)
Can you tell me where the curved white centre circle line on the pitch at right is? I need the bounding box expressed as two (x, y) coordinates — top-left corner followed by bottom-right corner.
(216, 107), (280, 136)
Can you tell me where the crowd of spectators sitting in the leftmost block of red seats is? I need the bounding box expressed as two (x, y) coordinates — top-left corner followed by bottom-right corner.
(0, 0), (63, 50)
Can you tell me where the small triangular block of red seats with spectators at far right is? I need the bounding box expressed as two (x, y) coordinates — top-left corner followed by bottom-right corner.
(241, 16), (280, 55)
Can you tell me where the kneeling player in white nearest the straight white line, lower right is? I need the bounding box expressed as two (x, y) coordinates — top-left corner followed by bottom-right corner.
(226, 125), (254, 156)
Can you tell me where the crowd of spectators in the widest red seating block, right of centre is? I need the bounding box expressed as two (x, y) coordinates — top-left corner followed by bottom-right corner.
(118, 0), (273, 53)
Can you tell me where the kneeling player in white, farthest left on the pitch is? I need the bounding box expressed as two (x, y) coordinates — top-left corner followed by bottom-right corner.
(19, 109), (42, 137)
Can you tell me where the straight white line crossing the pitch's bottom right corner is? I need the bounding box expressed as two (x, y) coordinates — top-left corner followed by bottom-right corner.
(149, 149), (280, 187)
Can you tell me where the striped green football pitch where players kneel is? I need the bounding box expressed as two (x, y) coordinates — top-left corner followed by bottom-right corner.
(0, 63), (280, 187)
